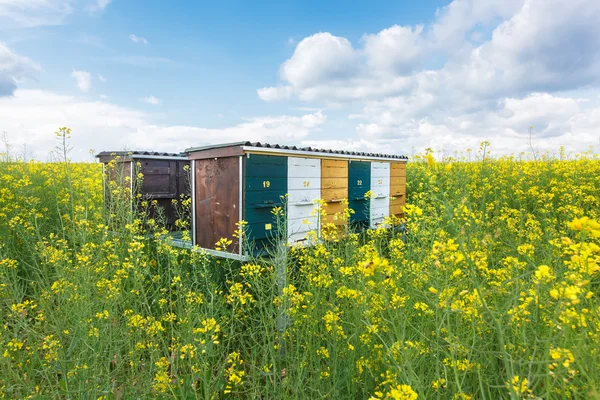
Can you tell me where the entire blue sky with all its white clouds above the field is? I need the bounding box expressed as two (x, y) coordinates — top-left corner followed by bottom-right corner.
(0, 0), (600, 159)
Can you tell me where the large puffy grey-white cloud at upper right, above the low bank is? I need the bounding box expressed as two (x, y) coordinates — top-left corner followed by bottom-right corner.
(258, 0), (600, 102)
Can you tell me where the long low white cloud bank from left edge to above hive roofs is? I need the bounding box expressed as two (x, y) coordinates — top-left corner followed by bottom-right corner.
(0, 89), (327, 160)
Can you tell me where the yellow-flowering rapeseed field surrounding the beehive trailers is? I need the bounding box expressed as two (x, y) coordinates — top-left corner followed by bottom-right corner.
(0, 137), (600, 399)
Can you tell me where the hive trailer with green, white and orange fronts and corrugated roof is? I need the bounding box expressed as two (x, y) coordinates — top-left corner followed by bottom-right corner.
(185, 142), (407, 259)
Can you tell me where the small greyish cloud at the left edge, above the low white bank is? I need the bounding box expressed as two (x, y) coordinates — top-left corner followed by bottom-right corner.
(0, 41), (41, 97)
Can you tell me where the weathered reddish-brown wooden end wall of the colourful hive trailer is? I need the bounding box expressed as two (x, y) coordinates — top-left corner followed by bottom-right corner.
(195, 157), (240, 252)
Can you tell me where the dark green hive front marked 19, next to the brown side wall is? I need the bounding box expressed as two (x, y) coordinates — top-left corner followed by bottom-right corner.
(244, 154), (288, 255)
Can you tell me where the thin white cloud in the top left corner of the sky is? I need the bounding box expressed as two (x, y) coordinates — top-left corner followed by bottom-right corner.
(0, 0), (74, 28)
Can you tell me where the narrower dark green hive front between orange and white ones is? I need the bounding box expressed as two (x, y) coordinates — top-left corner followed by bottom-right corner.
(348, 161), (371, 230)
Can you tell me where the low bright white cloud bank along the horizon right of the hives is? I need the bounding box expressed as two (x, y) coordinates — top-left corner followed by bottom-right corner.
(353, 93), (600, 154)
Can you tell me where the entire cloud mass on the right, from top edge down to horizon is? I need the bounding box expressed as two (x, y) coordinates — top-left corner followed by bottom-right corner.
(258, 0), (600, 152)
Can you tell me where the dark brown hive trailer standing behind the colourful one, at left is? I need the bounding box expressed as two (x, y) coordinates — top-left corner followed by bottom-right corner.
(96, 151), (190, 229)
